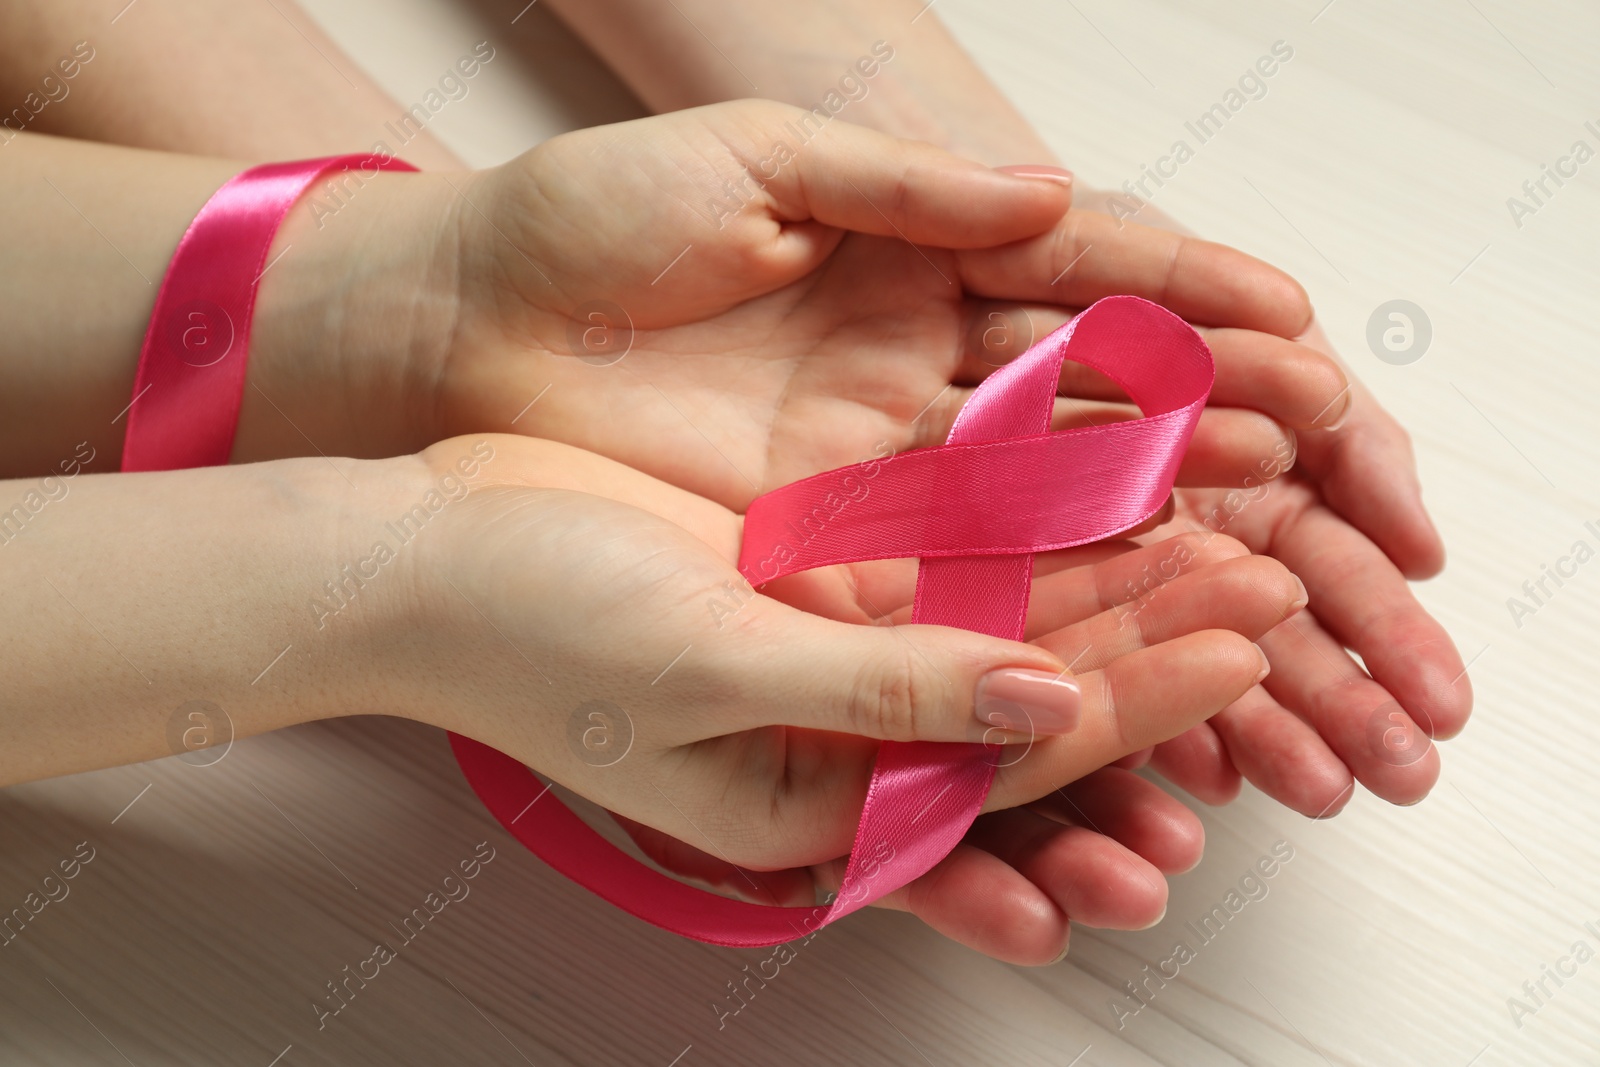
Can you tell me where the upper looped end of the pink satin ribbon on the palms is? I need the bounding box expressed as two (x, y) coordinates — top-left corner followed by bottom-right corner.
(739, 296), (1211, 584)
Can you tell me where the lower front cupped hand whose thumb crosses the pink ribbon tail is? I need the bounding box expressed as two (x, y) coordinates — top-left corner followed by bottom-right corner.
(394, 435), (1302, 963)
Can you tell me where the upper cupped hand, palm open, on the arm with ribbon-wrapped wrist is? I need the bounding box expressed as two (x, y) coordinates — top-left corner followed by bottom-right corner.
(259, 101), (1347, 507)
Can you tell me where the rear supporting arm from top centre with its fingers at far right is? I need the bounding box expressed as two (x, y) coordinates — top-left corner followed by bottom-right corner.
(489, 0), (1472, 816)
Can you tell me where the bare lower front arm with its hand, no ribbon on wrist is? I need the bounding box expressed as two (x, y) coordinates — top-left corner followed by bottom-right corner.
(0, 425), (1299, 940)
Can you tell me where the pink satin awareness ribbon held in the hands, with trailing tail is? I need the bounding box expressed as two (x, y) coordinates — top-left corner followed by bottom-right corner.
(451, 296), (1214, 945)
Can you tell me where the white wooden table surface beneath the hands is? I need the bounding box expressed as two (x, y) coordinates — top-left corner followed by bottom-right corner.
(0, 0), (1600, 1067)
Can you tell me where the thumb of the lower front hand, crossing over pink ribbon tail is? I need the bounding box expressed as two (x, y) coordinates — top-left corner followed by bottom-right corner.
(755, 605), (1080, 744)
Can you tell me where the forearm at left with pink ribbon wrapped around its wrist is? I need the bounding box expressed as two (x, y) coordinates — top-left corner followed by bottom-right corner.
(0, 134), (461, 477)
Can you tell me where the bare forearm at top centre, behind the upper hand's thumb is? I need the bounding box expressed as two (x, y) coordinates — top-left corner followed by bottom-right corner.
(549, 0), (1053, 166)
